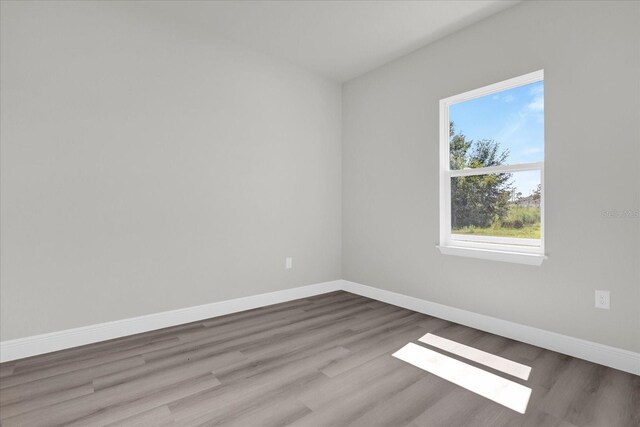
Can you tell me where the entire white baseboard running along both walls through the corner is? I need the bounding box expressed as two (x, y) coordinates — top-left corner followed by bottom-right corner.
(0, 280), (640, 375)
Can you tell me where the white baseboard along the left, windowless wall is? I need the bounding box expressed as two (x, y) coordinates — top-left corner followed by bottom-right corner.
(0, 280), (342, 362)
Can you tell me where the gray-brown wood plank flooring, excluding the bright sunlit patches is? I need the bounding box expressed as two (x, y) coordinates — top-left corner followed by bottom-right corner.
(0, 292), (640, 427)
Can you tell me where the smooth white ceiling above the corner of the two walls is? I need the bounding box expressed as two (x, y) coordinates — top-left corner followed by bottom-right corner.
(125, 0), (518, 82)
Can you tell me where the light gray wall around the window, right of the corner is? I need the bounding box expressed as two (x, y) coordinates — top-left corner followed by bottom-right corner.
(342, 2), (640, 351)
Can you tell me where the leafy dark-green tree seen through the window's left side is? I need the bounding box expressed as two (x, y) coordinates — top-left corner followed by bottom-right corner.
(449, 122), (512, 229)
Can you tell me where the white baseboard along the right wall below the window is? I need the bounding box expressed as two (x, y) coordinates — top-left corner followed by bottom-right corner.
(342, 280), (640, 375)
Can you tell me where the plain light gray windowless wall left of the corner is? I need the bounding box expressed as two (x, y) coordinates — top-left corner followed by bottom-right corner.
(0, 1), (341, 340)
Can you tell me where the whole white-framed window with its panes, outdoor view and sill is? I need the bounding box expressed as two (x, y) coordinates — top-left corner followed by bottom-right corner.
(438, 71), (544, 265)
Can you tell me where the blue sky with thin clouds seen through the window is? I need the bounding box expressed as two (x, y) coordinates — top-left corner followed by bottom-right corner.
(449, 82), (544, 195)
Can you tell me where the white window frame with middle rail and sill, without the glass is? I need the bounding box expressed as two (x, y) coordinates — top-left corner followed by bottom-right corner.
(438, 70), (546, 265)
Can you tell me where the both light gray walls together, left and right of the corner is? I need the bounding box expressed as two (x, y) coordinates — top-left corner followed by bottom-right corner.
(0, 1), (640, 351)
